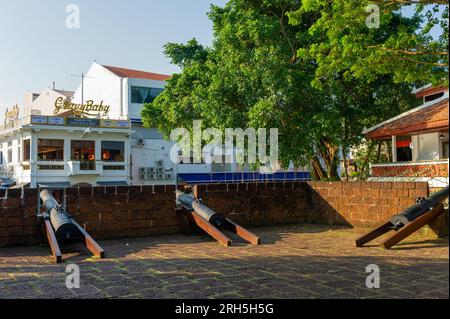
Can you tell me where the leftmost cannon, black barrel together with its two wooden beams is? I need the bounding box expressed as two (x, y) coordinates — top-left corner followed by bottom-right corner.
(38, 188), (105, 263)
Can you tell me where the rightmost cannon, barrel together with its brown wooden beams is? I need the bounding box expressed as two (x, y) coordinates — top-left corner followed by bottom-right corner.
(356, 186), (449, 249)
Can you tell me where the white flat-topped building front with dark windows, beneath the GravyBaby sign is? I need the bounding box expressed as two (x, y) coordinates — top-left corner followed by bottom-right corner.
(0, 115), (131, 187)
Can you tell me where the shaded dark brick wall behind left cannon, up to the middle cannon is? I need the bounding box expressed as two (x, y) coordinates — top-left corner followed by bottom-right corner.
(0, 186), (182, 246)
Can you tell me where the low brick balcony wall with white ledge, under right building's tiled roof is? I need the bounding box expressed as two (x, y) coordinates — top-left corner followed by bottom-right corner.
(371, 159), (449, 178)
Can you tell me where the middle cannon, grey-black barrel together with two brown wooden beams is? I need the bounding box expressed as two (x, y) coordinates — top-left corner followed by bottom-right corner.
(176, 190), (261, 246)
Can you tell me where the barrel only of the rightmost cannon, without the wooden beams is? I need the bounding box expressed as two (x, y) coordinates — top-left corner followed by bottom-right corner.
(391, 186), (449, 228)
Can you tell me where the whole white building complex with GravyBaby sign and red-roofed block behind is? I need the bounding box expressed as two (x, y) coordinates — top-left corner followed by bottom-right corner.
(0, 62), (310, 186)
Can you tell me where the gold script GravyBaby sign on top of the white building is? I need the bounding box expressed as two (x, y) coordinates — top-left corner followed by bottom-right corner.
(53, 97), (111, 117)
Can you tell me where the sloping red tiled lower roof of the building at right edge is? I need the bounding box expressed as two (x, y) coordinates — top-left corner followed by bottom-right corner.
(367, 98), (449, 140)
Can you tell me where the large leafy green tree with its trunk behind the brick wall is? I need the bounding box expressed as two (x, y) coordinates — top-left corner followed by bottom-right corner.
(142, 0), (441, 179)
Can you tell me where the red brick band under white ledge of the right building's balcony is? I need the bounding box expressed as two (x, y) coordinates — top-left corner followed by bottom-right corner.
(371, 163), (448, 177)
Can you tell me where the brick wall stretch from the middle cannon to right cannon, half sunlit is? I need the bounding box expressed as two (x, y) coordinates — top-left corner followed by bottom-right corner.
(195, 182), (428, 227)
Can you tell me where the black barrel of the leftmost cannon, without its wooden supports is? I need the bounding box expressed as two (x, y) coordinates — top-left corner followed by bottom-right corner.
(39, 189), (81, 239)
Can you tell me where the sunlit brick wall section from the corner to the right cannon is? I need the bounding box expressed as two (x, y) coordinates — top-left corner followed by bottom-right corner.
(307, 182), (429, 227)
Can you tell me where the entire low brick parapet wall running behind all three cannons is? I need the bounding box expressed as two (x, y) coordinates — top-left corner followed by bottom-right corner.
(0, 182), (436, 246)
